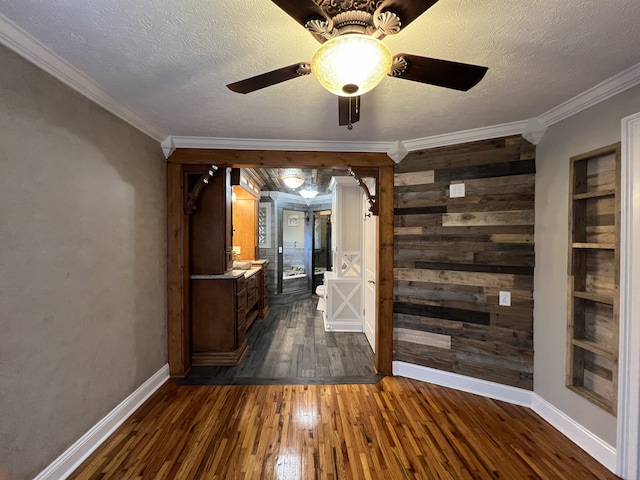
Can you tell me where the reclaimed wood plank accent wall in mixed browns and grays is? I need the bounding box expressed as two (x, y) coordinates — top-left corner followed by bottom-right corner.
(393, 136), (535, 390)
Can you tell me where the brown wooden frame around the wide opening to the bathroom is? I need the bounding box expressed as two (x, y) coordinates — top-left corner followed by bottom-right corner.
(167, 148), (394, 377)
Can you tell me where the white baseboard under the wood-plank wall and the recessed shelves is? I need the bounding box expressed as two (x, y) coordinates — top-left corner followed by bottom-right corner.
(393, 362), (617, 473)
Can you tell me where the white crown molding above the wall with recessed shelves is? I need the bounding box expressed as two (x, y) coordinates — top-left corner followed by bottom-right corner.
(538, 63), (640, 127)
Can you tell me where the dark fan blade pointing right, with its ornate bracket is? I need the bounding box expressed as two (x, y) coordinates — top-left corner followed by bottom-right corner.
(389, 53), (488, 92)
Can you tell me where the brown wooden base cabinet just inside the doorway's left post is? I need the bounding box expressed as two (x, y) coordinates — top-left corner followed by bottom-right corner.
(191, 274), (248, 365)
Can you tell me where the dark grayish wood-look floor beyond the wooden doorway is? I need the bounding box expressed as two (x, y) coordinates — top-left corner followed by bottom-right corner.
(178, 292), (382, 385)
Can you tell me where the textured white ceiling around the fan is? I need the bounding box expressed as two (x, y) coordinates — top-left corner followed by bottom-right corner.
(0, 0), (640, 141)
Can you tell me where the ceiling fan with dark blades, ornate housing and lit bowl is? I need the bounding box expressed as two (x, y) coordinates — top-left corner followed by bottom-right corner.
(227, 0), (488, 130)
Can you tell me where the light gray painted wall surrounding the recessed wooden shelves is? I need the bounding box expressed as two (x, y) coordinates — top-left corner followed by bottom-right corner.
(534, 82), (640, 446)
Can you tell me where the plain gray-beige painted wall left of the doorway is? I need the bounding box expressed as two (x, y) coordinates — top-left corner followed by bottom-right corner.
(0, 46), (167, 480)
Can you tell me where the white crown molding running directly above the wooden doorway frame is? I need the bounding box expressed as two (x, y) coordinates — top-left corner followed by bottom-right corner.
(172, 136), (393, 153)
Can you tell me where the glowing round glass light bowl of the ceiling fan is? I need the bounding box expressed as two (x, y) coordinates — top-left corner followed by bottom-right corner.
(311, 34), (393, 97)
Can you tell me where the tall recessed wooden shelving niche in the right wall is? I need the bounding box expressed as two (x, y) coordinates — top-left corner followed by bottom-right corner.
(566, 143), (620, 414)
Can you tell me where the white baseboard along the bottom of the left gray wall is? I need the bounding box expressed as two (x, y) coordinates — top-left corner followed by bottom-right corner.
(34, 364), (169, 480)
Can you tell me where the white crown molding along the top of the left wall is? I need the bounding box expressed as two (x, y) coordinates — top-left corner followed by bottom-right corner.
(0, 13), (167, 142)
